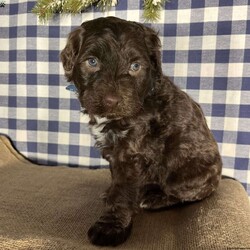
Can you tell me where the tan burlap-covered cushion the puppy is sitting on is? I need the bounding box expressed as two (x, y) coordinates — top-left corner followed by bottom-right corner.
(0, 136), (250, 250)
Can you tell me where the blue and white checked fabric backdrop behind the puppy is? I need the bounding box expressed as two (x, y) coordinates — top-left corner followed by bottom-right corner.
(0, 0), (250, 195)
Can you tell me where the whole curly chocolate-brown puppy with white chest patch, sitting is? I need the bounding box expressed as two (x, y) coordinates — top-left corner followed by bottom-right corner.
(61, 17), (222, 246)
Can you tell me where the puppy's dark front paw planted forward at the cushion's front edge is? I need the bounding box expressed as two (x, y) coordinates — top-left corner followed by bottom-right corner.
(88, 216), (132, 246)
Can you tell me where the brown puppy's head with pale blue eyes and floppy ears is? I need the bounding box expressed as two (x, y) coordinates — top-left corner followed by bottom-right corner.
(61, 17), (162, 119)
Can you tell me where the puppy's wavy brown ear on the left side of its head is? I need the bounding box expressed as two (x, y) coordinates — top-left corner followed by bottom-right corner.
(61, 27), (84, 82)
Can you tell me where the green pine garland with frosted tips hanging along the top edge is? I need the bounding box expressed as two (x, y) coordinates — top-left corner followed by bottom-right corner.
(32, 0), (168, 23)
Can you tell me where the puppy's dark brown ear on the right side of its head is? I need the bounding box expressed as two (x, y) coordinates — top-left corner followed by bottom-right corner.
(143, 26), (162, 80)
